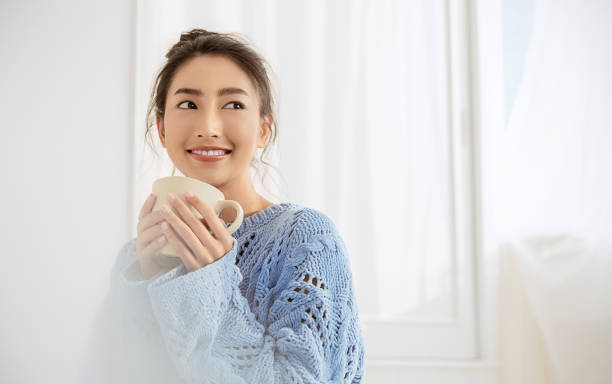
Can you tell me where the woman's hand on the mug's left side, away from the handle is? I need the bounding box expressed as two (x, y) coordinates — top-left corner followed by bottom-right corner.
(136, 194), (168, 279)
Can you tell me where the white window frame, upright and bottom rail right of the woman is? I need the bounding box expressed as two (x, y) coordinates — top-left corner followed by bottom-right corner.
(361, 0), (480, 364)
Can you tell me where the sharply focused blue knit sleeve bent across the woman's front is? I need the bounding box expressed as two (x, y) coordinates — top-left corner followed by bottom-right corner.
(147, 211), (364, 383)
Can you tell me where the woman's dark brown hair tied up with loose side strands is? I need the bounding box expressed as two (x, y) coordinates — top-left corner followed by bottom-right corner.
(145, 29), (278, 183)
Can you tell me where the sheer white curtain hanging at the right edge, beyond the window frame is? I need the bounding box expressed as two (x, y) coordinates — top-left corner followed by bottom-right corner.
(497, 0), (612, 384)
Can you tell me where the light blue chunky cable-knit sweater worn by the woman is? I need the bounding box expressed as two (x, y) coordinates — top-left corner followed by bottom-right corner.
(80, 203), (364, 383)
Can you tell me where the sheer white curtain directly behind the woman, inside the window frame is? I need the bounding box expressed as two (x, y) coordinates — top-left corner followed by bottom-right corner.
(134, 0), (452, 317)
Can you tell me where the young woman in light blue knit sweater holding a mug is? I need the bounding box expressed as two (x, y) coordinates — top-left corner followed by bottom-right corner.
(85, 29), (364, 383)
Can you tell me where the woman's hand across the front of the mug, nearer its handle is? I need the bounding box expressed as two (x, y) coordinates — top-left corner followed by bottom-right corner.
(159, 192), (234, 272)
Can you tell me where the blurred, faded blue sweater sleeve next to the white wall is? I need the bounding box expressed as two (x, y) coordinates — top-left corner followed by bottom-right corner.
(77, 239), (178, 384)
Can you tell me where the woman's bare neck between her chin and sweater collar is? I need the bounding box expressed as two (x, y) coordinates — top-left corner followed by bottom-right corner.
(217, 175), (273, 223)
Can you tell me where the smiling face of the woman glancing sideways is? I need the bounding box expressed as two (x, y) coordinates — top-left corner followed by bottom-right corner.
(157, 55), (269, 187)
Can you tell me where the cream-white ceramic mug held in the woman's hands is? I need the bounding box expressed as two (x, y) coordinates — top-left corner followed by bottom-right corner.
(153, 176), (244, 268)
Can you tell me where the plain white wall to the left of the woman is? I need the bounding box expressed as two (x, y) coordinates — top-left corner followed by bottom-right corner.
(0, 0), (133, 383)
